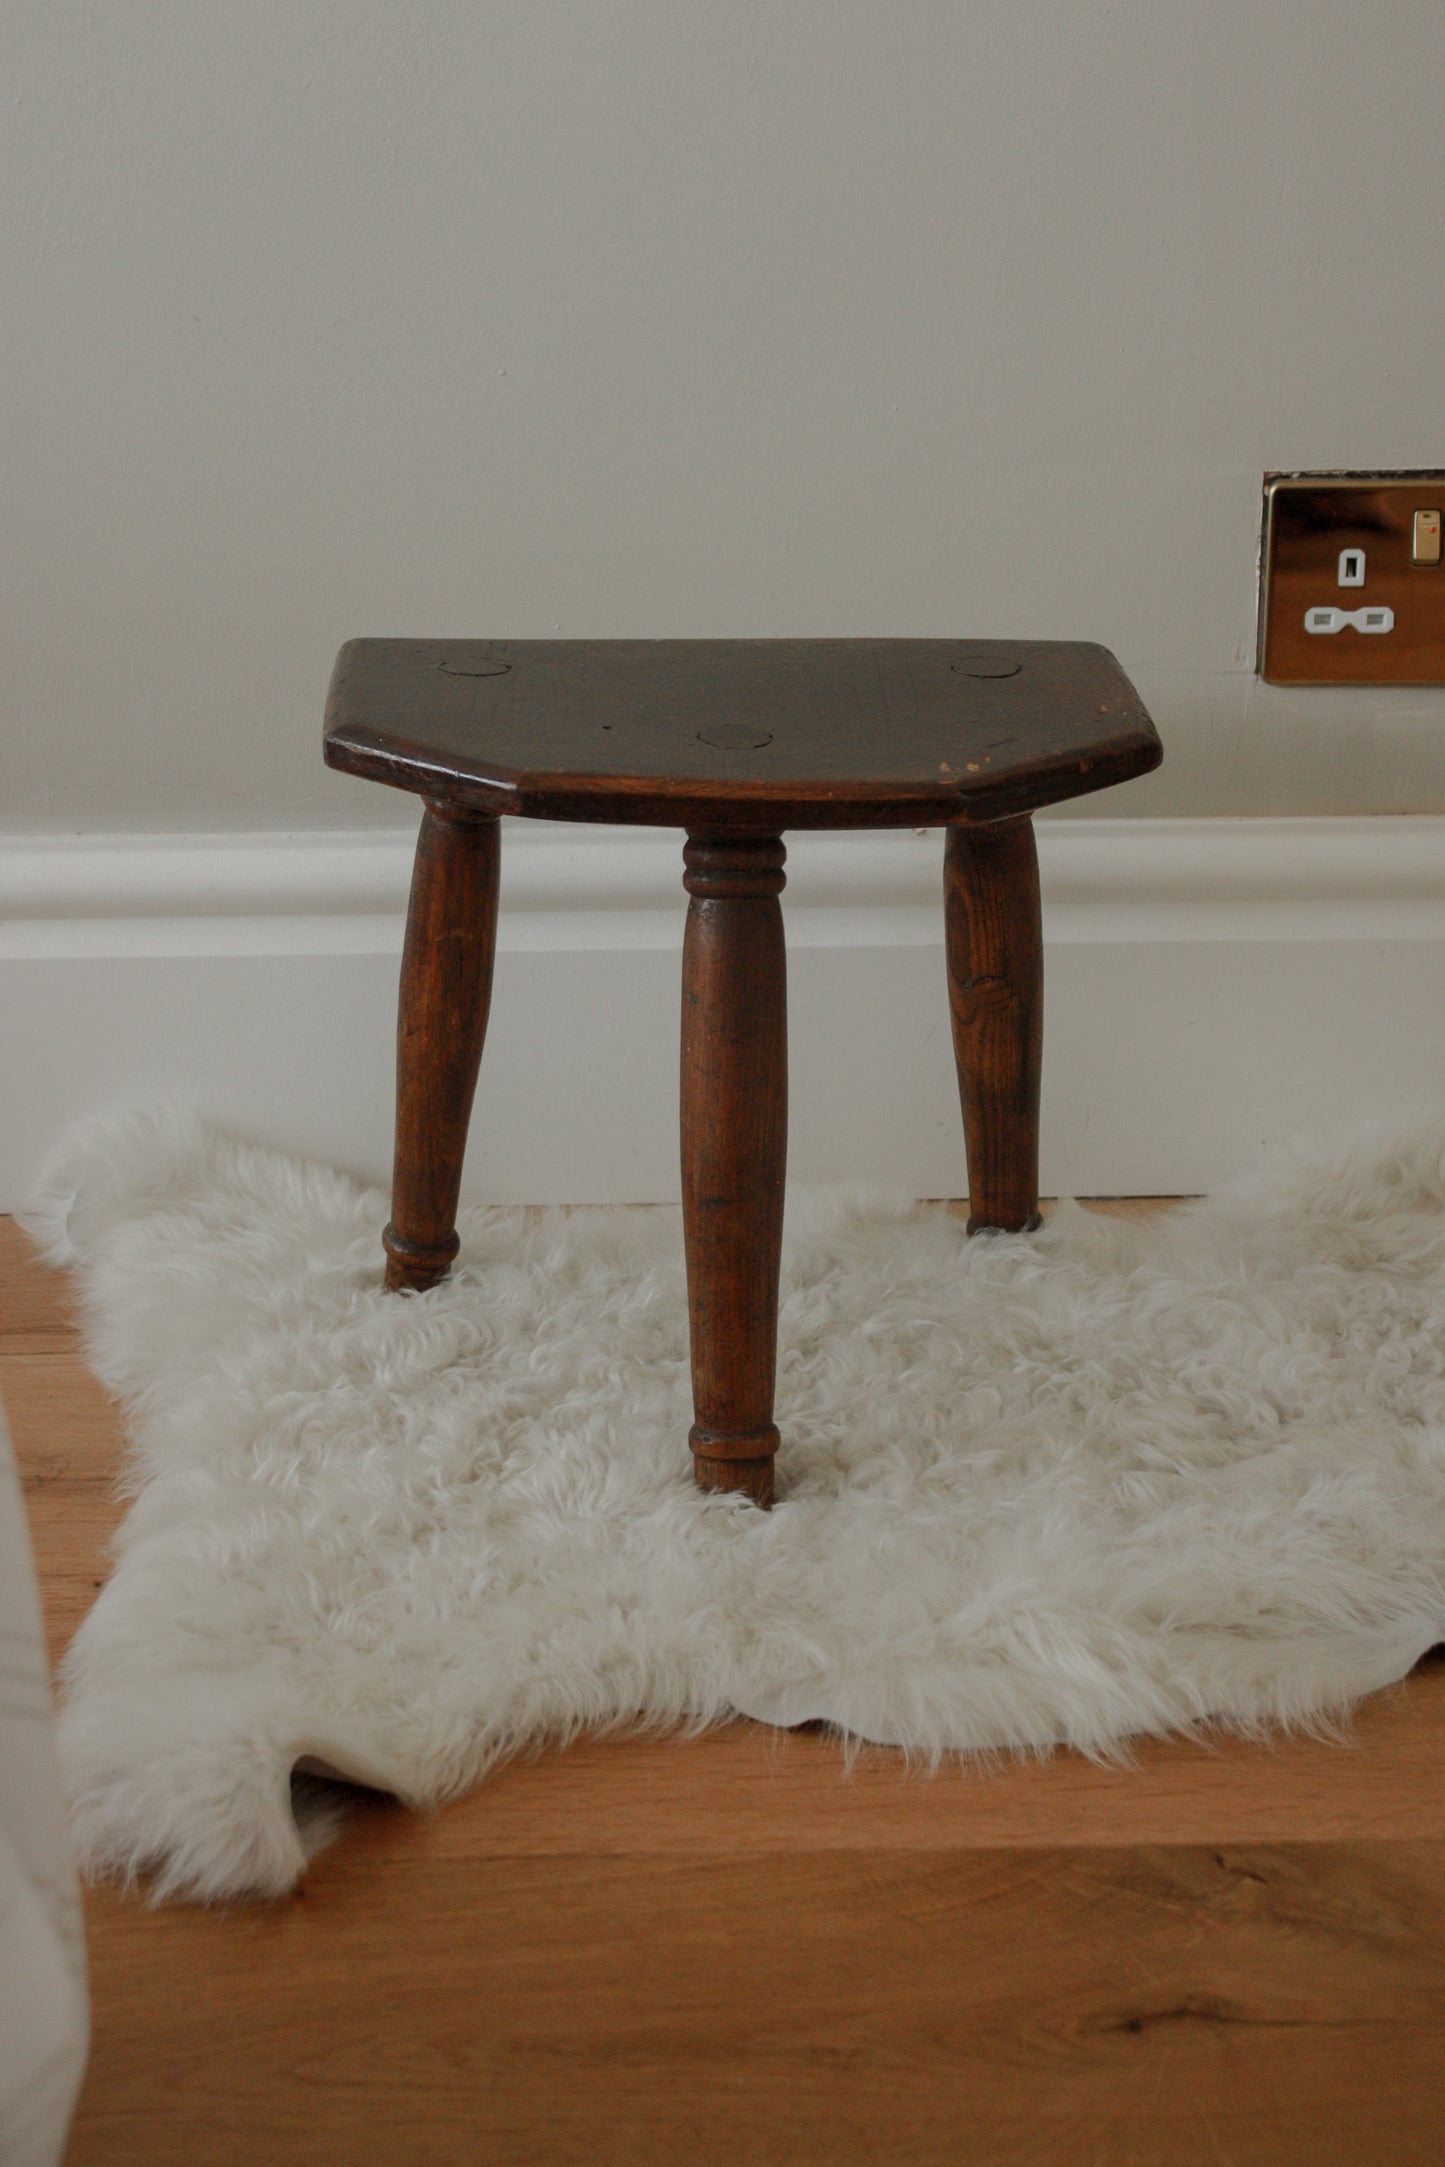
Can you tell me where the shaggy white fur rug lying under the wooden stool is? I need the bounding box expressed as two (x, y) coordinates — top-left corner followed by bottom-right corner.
(28, 1114), (1445, 1898)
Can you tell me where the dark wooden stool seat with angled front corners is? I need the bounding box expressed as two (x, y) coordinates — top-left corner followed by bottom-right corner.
(325, 639), (1161, 832)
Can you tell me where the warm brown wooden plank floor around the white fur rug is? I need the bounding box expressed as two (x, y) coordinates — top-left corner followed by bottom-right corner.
(0, 1222), (1445, 2167)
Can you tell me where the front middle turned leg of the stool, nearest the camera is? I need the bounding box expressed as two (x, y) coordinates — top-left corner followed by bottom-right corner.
(682, 834), (789, 1506)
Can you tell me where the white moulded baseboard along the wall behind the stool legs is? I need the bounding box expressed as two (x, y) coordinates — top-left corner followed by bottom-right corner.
(0, 817), (1445, 1209)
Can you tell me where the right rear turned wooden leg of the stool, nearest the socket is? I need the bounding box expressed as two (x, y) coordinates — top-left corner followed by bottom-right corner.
(942, 819), (1044, 1233)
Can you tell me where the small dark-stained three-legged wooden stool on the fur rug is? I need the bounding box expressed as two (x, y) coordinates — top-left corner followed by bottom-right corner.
(325, 639), (1161, 1504)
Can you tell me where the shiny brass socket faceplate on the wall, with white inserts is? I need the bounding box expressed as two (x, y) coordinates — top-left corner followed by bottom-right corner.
(1259, 470), (1445, 685)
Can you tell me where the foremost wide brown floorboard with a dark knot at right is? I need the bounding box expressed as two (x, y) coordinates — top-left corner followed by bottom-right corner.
(69, 1844), (1445, 2167)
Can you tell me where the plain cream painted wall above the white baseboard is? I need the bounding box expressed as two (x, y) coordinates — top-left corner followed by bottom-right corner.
(0, 0), (1445, 830)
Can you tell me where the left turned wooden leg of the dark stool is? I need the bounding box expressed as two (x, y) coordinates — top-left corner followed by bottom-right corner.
(381, 804), (500, 1292)
